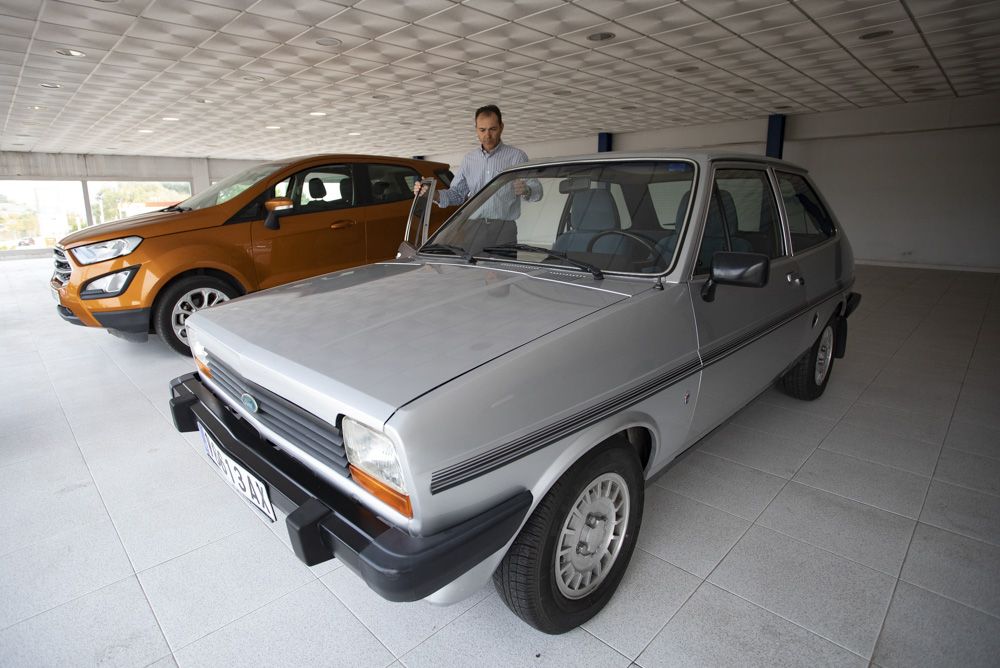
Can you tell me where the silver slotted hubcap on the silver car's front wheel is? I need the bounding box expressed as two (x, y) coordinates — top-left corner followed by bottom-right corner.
(554, 473), (629, 599)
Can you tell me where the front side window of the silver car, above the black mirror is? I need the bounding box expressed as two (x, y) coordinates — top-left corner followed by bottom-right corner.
(695, 169), (782, 274)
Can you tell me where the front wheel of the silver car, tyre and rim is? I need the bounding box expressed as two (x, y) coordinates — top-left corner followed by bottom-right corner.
(493, 439), (645, 634)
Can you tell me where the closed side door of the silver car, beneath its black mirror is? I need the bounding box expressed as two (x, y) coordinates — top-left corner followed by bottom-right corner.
(690, 164), (808, 436)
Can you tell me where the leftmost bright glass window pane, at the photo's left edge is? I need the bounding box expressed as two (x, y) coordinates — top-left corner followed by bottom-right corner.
(0, 180), (87, 250)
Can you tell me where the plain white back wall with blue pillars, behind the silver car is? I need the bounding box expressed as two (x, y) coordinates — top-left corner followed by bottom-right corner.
(427, 95), (1000, 271)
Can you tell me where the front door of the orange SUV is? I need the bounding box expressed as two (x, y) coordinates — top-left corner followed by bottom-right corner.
(251, 164), (365, 289)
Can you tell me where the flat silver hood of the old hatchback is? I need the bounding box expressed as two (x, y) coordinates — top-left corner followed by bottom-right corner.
(187, 263), (632, 424)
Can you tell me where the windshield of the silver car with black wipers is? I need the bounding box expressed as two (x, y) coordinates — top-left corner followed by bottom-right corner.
(428, 160), (695, 277)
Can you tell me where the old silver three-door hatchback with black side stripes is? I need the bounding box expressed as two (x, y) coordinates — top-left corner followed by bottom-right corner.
(171, 153), (860, 633)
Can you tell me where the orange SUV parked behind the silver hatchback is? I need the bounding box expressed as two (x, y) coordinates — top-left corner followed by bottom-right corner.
(51, 155), (453, 354)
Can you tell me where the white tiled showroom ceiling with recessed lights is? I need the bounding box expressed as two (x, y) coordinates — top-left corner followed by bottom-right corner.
(0, 0), (1000, 158)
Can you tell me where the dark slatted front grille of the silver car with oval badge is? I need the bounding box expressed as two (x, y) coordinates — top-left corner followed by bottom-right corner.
(208, 357), (351, 478)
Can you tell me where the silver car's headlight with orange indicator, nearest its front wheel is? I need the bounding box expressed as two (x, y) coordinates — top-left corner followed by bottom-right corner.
(341, 418), (413, 517)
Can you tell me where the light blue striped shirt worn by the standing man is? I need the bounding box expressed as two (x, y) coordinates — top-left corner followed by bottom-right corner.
(438, 142), (537, 220)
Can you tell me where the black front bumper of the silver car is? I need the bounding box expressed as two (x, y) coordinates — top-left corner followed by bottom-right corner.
(170, 373), (532, 601)
